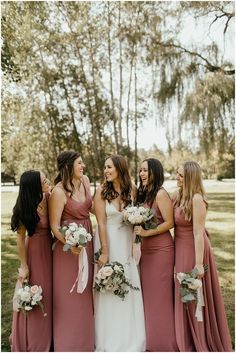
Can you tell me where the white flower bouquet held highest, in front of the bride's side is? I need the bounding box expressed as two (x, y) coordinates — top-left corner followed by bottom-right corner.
(123, 205), (158, 243)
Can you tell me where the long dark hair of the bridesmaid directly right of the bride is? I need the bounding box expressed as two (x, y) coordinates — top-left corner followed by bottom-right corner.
(136, 158), (164, 207)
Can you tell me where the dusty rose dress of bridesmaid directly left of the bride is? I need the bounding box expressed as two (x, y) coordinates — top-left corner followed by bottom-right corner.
(53, 183), (95, 352)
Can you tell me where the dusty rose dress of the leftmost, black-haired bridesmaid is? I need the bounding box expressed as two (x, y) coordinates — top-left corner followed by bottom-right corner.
(10, 194), (52, 352)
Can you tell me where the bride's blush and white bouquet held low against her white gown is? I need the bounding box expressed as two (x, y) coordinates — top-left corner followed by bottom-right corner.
(94, 261), (139, 300)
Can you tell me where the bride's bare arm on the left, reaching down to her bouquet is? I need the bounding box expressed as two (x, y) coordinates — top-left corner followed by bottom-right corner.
(94, 186), (108, 267)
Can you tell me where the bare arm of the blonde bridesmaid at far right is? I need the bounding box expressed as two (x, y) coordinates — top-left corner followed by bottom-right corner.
(193, 194), (206, 277)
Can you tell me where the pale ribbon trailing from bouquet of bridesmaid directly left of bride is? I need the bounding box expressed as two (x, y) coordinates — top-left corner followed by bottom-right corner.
(70, 248), (88, 293)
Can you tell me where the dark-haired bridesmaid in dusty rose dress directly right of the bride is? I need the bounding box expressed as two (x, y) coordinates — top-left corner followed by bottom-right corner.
(134, 158), (177, 352)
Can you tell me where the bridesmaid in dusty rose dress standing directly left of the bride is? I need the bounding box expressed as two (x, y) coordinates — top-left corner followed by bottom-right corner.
(49, 151), (95, 352)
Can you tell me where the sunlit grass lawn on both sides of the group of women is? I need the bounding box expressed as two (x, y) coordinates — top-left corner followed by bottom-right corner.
(1, 181), (235, 352)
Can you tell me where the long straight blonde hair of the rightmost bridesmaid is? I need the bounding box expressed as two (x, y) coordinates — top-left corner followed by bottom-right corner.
(174, 161), (208, 222)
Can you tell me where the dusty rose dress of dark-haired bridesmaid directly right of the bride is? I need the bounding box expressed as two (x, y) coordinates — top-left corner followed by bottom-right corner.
(140, 194), (177, 352)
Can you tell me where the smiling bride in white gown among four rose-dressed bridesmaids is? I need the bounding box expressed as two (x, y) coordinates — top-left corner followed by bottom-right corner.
(94, 155), (146, 352)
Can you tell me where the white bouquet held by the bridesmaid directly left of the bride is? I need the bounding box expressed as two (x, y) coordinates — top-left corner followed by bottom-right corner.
(60, 222), (92, 251)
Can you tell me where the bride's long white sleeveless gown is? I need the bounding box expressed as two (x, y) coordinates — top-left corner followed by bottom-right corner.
(94, 201), (146, 352)
